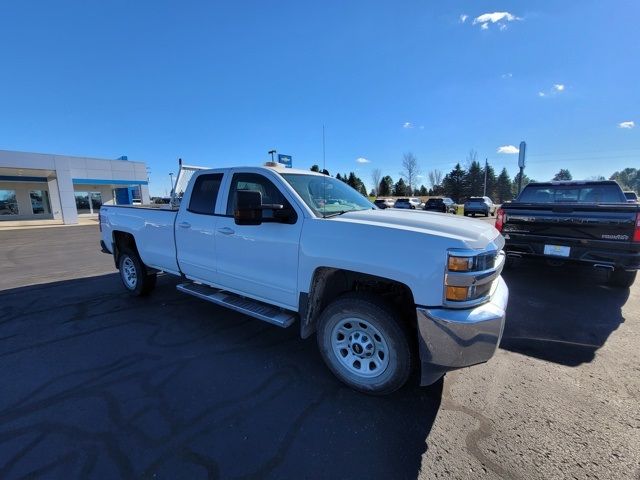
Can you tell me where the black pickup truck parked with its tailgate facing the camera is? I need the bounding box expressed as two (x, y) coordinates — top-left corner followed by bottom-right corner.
(496, 181), (640, 287)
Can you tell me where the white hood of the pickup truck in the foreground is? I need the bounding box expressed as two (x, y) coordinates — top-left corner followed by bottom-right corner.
(330, 209), (504, 249)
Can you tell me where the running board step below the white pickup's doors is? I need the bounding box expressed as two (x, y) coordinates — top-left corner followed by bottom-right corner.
(176, 283), (296, 328)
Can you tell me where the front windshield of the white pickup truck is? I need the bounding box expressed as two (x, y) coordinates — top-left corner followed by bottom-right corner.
(282, 173), (377, 217)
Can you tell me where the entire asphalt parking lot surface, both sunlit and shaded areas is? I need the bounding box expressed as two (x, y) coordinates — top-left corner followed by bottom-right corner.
(0, 226), (640, 479)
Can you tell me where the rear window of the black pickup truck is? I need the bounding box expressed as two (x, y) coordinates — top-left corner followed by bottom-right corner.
(517, 184), (625, 203)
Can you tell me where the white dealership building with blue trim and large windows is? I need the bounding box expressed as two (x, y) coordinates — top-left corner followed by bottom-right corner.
(0, 150), (149, 226)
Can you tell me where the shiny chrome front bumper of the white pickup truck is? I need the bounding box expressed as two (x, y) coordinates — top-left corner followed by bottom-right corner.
(416, 277), (509, 385)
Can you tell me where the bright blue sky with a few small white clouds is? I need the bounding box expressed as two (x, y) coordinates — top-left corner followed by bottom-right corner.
(0, 0), (640, 194)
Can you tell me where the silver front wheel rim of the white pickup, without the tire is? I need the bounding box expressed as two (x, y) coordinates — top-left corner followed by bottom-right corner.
(331, 318), (389, 378)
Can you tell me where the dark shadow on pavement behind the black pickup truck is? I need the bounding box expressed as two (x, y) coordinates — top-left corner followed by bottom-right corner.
(500, 260), (629, 367)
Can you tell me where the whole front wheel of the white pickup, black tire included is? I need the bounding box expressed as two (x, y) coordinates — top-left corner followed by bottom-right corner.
(317, 293), (413, 395)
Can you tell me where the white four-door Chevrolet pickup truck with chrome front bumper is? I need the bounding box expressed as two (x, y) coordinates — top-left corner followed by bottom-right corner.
(100, 164), (508, 394)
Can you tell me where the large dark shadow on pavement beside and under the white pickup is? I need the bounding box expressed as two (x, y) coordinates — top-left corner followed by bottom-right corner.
(0, 274), (442, 479)
